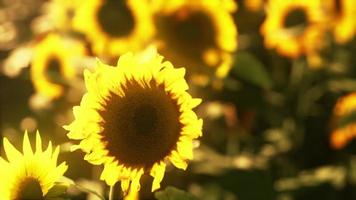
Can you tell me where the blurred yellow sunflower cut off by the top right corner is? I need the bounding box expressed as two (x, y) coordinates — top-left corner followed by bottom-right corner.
(324, 0), (356, 43)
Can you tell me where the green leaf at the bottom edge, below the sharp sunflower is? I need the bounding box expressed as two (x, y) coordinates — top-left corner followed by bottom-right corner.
(155, 186), (197, 200)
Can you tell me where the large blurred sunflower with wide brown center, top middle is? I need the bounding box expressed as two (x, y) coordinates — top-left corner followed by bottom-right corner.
(152, 0), (237, 80)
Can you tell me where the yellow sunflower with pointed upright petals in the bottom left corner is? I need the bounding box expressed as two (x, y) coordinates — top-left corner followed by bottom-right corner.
(0, 132), (68, 200)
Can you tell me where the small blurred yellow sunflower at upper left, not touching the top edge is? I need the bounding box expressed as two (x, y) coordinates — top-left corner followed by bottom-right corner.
(30, 33), (86, 99)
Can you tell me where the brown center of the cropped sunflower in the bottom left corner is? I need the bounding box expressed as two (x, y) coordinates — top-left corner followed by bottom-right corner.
(14, 178), (44, 200)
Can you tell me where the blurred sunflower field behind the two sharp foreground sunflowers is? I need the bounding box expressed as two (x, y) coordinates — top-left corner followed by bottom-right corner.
(0, 0), (356, 200)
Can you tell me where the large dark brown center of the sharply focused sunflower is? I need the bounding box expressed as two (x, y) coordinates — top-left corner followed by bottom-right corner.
(99, 80), (181, 168)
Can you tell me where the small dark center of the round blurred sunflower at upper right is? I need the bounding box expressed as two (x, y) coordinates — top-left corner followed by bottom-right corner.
(284, 8), (308, 28)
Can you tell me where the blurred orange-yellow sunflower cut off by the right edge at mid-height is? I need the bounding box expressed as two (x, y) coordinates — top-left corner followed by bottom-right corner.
(330, 93), (356, 149)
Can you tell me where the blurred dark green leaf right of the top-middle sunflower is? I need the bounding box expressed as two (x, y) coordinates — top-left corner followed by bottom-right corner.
(232, 51), (272, 89)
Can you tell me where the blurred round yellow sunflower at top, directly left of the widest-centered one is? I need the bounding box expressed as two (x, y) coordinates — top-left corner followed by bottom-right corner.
(73, 0), (154, 57)
